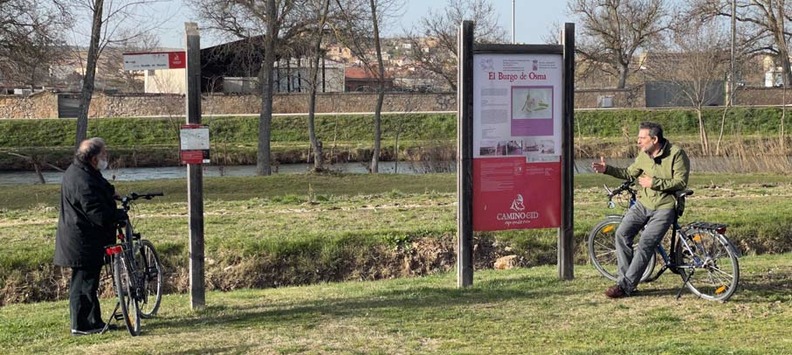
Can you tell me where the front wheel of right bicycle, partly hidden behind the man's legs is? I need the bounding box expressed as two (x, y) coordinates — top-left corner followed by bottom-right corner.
(588, 216), (656, 281)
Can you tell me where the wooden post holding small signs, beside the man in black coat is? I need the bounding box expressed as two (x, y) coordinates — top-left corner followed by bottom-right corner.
(184, 22), (206, 310)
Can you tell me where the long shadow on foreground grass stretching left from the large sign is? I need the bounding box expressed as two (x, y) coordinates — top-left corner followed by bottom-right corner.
(146, 276), (576, 333)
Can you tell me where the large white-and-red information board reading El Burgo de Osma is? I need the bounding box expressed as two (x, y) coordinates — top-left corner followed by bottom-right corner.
(473, 53), (564, 231)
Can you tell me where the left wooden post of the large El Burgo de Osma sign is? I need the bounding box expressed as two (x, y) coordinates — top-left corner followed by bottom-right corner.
(457, 21), (473, 288)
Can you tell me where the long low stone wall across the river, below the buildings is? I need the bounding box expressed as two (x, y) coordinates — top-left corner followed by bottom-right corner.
(0, 87), (792, 118)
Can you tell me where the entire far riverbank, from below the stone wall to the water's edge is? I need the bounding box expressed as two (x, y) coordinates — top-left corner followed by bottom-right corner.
(0, 108), (792, 172)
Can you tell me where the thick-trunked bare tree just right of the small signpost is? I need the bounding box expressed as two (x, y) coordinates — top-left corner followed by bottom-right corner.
(190, 0), (315, 175)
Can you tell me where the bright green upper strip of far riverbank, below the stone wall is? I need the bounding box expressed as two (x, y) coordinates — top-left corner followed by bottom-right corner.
(0, 107), (783, 148)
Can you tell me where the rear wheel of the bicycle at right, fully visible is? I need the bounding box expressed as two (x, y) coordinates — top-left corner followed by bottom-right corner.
(676, 229), (740, 301)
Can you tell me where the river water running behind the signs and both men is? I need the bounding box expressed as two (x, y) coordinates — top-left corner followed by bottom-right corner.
(0, 157), (792, 186)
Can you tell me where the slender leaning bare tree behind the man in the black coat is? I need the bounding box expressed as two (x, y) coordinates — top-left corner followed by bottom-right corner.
(67, 0), (175, 145)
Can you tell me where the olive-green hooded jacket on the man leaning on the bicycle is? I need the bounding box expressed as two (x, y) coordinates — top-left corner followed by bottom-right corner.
(605, 140), (690, 210)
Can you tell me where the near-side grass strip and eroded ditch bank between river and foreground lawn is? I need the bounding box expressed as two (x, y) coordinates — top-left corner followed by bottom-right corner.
(0, 174), (792, 304)
